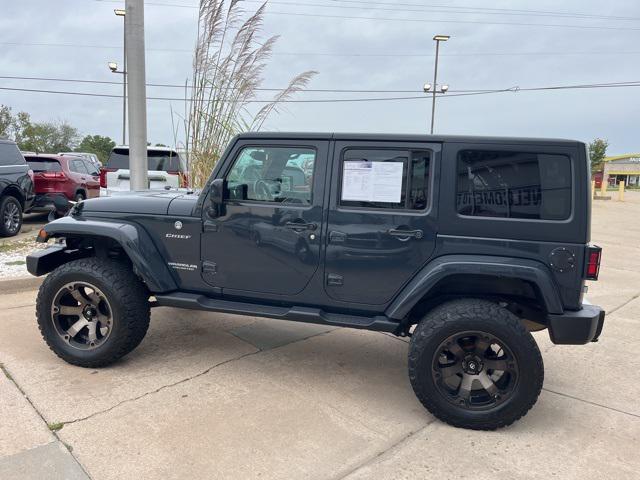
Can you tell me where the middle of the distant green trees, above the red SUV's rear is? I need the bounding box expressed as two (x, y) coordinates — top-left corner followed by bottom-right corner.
(16, 121), (80, 153)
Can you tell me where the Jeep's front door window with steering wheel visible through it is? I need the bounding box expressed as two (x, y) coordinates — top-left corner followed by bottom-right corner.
(227, 147), (316, 205)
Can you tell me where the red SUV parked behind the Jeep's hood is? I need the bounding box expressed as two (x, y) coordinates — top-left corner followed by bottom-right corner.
(25, 155), (100, 210)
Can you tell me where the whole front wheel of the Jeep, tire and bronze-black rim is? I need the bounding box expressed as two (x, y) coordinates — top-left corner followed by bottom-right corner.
(36, 258), (150, 368)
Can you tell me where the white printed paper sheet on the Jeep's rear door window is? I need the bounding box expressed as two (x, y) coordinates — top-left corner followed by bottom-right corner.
(342, 161), (404, 203)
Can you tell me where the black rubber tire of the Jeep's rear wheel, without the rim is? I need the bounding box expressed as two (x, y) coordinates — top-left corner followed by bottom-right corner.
(409, 299), (544, 430)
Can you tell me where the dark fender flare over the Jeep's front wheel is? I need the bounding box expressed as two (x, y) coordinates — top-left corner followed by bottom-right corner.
(37, 216), (178, 293)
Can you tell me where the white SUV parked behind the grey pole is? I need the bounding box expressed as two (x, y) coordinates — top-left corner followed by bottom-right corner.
(100, 147), (189, 195)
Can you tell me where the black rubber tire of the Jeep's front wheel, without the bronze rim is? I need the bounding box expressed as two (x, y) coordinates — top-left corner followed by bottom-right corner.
(36, 257), (150, 368)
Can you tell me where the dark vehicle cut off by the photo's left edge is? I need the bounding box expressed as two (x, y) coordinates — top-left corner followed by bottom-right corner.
(0, 139), (34, 237)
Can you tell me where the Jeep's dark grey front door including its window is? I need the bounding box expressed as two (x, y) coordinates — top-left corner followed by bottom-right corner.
(202, 140), (329, 298)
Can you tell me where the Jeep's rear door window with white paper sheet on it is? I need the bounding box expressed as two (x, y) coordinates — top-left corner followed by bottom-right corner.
(340, 149), (431, 210)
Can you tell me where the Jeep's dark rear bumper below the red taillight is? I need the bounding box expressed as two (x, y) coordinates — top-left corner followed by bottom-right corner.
(547, 303), (605, 345)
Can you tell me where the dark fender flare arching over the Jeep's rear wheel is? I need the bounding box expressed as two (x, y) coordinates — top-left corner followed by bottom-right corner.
(385, 255), (564, 320)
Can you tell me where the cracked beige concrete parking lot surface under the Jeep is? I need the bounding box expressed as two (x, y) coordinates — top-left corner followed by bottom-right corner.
(0, 192), (640, 480)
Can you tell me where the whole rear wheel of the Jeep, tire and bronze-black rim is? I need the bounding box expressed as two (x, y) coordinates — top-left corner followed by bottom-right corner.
(409, 299), (544, 430)
